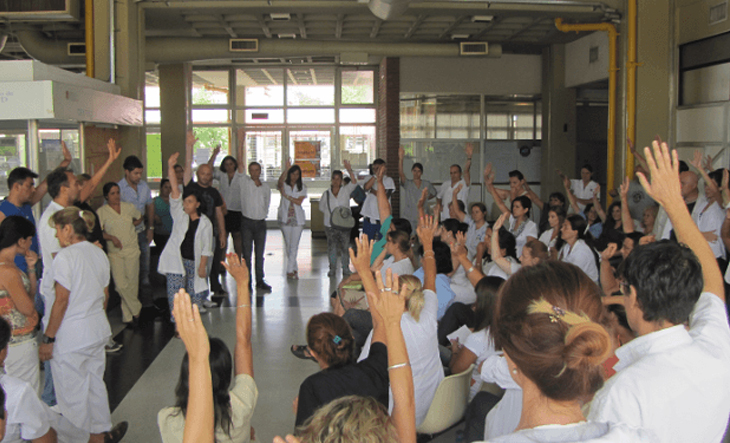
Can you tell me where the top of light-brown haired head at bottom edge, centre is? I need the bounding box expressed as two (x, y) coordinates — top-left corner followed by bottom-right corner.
(297, 395), (398, 443)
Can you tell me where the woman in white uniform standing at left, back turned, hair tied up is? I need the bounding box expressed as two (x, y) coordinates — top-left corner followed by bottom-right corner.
(39, 207), (121, 442)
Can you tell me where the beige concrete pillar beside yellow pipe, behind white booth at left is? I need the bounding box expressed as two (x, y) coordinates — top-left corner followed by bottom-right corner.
(114, 0), (147, 175)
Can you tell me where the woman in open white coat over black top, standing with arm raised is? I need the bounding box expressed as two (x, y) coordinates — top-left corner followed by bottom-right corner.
(157, 153), (213, 321)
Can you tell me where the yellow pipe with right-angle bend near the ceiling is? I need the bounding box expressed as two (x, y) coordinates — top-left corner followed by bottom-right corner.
(555, 18), (618, 200)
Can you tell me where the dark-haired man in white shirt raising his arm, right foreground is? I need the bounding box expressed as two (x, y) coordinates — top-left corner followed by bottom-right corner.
(587, 142), (730, 443)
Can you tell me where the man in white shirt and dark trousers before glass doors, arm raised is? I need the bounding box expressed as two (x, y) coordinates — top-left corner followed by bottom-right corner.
(237, 143), (271, 292)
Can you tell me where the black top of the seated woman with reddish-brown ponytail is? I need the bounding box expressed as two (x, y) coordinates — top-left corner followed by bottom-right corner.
(296, 342), (390, 426)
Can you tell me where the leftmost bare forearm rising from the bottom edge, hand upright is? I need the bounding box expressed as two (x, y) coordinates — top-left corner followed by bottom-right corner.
(172, 289), (215, 443)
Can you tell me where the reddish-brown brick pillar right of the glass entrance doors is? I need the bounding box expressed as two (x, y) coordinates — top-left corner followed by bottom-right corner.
(377, 57), (400, 218)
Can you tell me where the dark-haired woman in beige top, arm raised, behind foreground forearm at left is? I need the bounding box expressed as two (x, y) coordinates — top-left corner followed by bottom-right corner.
(157, 254), (259, 443)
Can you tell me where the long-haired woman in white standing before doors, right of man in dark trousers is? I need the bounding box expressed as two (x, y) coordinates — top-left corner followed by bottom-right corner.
(277, 160), (307, 280)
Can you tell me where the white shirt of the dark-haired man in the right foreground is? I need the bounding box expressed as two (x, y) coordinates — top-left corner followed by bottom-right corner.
(586, 293), (730, 443)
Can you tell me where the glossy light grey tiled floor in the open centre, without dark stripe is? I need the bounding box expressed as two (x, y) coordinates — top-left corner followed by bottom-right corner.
(112, 230), (456, 443)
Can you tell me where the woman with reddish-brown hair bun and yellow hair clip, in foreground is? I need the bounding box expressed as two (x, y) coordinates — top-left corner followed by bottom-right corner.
(478, 261), (656, 443)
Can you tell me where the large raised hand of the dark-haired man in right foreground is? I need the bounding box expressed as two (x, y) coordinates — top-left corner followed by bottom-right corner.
(638, 141), (684, 211)
